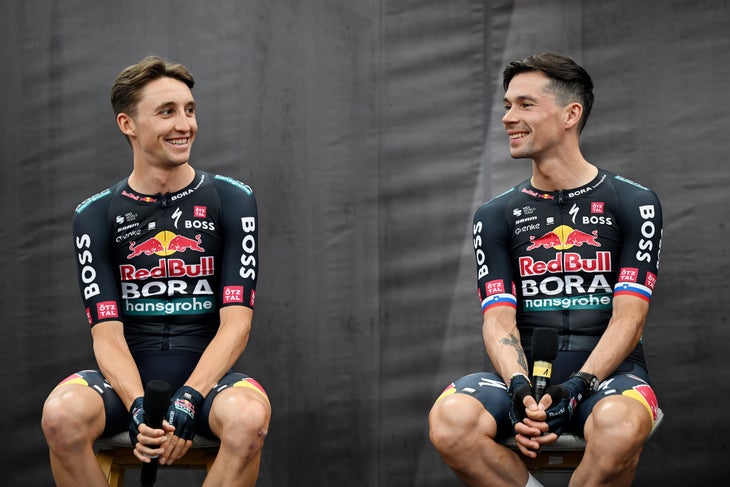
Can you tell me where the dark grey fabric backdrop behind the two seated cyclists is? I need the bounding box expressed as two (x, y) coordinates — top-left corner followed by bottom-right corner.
(0, 0), (730, 487)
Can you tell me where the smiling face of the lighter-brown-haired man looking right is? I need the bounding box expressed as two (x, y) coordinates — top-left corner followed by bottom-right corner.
(117, 77), (198, 168)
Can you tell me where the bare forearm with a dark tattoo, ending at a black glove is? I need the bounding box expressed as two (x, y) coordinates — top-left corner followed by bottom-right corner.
(482, 307), (528, 385)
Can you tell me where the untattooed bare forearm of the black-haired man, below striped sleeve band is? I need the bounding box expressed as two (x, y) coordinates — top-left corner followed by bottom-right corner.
(581, 296), (649, 380)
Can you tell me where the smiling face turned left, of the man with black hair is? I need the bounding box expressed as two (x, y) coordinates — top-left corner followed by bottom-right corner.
(502, 71), (580, 160)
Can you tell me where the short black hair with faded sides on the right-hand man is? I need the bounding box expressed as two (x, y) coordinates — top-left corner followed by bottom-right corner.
(502, 53), (593, 133)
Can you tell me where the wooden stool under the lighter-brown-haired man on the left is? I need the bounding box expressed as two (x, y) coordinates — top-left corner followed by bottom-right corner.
(94, 432), (220, 487)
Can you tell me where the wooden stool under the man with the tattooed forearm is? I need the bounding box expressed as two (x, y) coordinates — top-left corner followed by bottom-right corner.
(502, 409), (664, 473)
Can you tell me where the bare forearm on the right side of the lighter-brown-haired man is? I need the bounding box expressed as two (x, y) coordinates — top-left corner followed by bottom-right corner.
(185, 306), (253, 396)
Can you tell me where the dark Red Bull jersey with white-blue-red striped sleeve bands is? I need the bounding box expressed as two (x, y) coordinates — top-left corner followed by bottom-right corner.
(473, 170), (662, 366)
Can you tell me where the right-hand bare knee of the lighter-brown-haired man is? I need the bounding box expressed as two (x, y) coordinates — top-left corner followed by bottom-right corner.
(216, 389), (271, 454)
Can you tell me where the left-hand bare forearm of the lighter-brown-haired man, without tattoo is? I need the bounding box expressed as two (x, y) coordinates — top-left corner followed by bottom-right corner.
(92, 322), (144, 409)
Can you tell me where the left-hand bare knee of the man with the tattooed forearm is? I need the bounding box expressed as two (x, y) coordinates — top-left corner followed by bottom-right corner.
(428, 394), (485, 454)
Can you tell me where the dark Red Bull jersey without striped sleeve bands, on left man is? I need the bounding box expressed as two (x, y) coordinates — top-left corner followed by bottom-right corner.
(73, 171), (258, 354)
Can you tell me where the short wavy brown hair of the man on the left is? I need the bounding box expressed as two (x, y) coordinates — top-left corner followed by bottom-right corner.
(111, 56), (195, 116)
